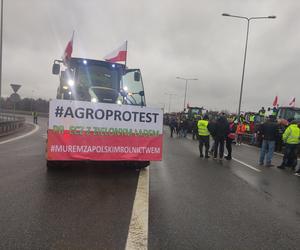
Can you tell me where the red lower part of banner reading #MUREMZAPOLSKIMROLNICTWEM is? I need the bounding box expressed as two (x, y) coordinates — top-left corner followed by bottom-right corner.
(47, 130), (163, 161)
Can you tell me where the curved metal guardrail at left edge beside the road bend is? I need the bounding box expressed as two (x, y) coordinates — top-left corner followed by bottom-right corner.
(0, 114), (25, 136)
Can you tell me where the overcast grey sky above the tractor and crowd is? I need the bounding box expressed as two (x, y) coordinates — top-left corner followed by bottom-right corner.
(2, 0), (300, 111)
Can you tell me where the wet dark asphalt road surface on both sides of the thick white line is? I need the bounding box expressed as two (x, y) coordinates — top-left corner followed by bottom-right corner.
(0, 118), (300, 249)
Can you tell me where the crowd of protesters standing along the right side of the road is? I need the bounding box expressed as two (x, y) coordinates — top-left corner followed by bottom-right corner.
(169, 110), (300, 175)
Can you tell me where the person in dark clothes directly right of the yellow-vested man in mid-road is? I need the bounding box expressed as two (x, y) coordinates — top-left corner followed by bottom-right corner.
(214, 115), (229, 160)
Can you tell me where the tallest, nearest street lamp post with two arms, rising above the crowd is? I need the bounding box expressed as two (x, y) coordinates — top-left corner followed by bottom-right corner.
(222, 13), (276, 121)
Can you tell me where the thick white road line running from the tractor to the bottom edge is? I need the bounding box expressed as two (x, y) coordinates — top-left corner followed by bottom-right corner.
(125, 167), (149, 250)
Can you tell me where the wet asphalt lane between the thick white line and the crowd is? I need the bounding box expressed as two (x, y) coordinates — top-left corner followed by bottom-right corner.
(149, 131), (300, 249)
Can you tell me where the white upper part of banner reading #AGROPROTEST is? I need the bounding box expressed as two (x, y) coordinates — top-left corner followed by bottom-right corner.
(49, 100), (163, 134)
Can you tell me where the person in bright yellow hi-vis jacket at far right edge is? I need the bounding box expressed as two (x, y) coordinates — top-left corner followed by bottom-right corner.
(278, 121), (300, 169)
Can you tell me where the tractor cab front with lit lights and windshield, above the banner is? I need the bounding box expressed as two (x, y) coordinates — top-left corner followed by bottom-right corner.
(57, 58), (145, 106)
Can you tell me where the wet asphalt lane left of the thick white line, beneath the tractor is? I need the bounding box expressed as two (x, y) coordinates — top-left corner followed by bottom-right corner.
(0, 118), (139, 249)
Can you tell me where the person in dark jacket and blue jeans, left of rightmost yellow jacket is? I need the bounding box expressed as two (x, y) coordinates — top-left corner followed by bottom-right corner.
(259, 115), (279, 167)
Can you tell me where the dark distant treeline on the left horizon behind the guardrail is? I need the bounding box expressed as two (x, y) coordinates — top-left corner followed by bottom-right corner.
(0, 97), (49, 113)
